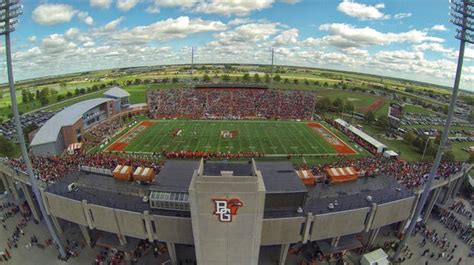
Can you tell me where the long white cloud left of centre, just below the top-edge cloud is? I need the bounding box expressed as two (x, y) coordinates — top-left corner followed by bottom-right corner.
(110, 16), (226, 44)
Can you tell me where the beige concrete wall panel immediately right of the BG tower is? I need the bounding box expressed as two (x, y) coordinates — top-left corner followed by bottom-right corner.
(260, 217), (305, 246)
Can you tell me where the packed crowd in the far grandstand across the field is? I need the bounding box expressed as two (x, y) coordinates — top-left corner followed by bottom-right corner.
(147, 88), (316, 119)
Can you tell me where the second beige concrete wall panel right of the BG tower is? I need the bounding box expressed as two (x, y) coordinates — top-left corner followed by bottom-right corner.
(310, 208), (370, 241)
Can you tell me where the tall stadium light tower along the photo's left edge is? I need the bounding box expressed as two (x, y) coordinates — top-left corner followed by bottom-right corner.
(0, 0), (67, 259)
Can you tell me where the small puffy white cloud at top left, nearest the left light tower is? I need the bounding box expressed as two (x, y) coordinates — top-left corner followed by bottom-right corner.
(32, 4), (77, 26)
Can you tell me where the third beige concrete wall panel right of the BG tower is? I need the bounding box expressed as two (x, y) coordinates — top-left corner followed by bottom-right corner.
(371, 196), (415, 229)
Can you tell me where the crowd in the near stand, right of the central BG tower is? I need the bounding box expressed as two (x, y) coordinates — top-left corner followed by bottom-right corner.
(304, 157), (462, 188)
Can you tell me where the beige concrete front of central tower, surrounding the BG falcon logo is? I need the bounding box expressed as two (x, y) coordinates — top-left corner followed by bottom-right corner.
(189, 169), (265, 265)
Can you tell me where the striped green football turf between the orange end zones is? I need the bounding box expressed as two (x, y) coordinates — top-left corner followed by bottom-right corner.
(125, 120), (337, 154)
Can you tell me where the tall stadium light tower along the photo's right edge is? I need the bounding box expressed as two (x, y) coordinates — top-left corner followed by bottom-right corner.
(392, 0), (474, 261)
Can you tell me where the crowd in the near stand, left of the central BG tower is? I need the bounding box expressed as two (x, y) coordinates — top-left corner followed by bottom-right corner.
(9, 154), (162, 182)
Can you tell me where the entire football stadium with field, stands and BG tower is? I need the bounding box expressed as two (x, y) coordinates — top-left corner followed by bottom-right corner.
(0, 84), (472, 265)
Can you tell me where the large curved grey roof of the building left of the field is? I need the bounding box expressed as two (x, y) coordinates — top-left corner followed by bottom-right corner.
(31, 98), (111, 146)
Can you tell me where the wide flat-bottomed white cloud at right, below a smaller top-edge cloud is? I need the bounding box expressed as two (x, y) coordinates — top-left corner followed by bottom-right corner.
(312, 23), (444, 48)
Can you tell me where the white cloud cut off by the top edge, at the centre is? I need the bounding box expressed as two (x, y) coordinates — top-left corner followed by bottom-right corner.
(195, 0), (274, 16)
